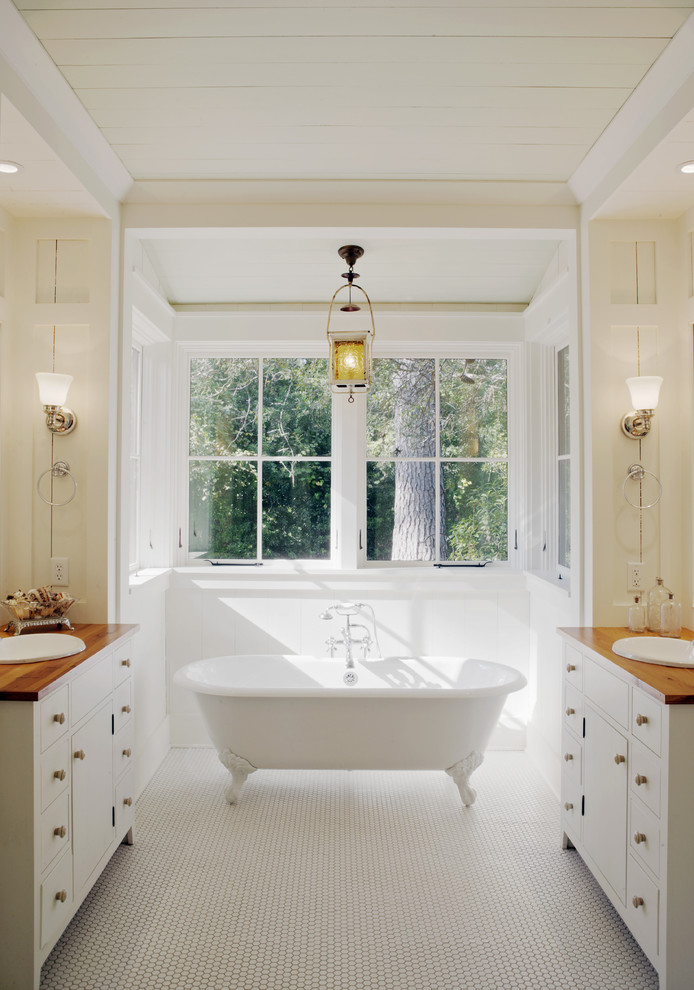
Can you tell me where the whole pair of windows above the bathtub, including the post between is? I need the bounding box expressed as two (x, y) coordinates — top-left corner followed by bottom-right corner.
(182, 345), (519, 567)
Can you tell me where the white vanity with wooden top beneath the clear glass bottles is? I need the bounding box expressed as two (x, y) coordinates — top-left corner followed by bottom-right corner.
(559, 627), (694, 990)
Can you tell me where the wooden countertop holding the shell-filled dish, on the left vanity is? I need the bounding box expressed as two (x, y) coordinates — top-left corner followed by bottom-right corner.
(0, 622), (139, 701)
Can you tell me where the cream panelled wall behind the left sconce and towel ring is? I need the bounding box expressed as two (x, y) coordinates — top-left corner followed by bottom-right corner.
(0, 219), (115, 621)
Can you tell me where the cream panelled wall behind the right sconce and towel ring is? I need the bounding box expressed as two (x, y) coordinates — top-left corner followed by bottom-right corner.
(588, 221), (692, 625)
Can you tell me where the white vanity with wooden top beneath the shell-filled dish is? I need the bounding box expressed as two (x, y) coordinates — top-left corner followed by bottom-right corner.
(0, 623), (138, 990)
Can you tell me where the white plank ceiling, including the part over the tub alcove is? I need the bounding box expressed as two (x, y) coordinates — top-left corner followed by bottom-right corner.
(0, 0), (694, 303)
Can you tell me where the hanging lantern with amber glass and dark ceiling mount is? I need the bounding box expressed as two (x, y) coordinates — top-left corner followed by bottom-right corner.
(327, 244), (376, 402)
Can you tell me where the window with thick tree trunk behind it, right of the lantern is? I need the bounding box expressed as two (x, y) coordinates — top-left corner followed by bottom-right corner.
(366, 358), (508, 561)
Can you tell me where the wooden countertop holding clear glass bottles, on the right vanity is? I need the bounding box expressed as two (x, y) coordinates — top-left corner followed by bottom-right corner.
(558, 626), (694, 705)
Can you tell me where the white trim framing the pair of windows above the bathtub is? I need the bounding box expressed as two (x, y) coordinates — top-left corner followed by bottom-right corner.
(173, 339), (525, 574)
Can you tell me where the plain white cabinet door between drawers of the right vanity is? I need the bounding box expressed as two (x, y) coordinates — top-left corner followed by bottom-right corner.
(583, 705), (628, 903)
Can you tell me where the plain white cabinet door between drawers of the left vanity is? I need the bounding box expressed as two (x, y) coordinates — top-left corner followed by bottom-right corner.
(71, 702), (114, 895)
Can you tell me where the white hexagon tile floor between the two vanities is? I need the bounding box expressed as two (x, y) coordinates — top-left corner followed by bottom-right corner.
(41, 749), (658, 990)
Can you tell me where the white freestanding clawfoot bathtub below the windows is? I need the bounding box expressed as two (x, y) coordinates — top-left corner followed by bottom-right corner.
(174, 655), (526, 805)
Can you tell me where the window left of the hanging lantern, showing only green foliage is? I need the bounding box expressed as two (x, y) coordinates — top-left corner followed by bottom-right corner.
(188, 357), (331, 560)
